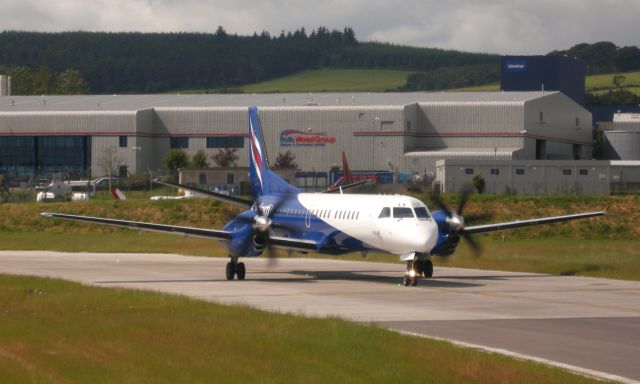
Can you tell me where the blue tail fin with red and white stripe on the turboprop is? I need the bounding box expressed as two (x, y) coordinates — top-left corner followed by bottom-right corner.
(249, 107), (300, 200)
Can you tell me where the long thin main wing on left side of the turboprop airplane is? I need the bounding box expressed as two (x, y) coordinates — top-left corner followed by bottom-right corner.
(41, 212), (231, 240)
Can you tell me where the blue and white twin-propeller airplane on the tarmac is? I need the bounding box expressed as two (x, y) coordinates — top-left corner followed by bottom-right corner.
(42, 107), (605, 286)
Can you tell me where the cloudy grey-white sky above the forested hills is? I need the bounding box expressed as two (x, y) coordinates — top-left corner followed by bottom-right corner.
(5, 0), (640, 54)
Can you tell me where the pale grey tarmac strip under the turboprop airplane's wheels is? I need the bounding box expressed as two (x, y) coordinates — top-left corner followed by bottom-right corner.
(0, 251), (640, 382)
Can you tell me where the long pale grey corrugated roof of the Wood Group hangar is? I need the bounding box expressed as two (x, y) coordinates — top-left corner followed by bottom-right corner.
(0, 92), (555, 112)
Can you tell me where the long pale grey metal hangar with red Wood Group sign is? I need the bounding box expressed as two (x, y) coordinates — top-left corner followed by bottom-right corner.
(0, 92), (592, 183)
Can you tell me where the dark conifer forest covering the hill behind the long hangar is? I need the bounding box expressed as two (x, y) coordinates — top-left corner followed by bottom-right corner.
(0, 27), (499, 94)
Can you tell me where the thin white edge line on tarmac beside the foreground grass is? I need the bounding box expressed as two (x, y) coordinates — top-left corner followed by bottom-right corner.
(387, 328), (640, 384)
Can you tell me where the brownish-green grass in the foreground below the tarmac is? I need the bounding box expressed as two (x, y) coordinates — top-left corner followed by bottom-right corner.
(0, 275), (596, 383)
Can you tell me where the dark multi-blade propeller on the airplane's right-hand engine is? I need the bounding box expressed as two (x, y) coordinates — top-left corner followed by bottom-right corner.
(429, 184), (491, 257)
